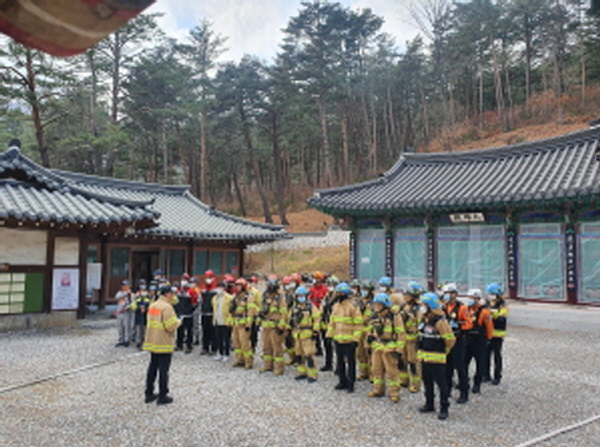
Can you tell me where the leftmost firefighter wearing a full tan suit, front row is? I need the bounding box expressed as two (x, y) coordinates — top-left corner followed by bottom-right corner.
(230, 278), (258, 369)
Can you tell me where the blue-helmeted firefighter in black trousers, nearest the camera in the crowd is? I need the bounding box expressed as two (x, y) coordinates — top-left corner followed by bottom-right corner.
(418, 292), (456, 420)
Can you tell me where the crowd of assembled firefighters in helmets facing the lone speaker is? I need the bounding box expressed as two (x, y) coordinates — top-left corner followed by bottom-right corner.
(125, 271), (508, 419)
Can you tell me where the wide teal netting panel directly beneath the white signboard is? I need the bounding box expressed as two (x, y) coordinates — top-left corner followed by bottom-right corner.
(437, 225), (506, 293)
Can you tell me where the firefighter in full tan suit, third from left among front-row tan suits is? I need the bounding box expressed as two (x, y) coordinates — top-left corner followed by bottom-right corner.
(288, 286), (321, 383)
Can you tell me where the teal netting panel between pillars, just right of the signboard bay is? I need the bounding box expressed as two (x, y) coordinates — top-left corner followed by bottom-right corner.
(519, 224), (565, 301)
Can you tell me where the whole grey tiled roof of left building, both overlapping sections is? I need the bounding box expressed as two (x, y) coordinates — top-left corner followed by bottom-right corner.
(0, 148), (287, 243)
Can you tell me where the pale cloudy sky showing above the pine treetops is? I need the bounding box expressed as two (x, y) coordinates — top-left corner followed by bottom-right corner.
(148, 0), (418, 61)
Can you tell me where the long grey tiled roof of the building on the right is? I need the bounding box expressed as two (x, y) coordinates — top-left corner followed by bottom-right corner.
(309, 127), (600, 216)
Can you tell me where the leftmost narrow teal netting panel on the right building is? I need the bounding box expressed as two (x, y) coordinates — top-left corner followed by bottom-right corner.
(356, 230), (385, 281)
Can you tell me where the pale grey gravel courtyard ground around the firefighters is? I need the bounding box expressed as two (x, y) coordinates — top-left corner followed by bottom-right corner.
(0, 323), (600, 447)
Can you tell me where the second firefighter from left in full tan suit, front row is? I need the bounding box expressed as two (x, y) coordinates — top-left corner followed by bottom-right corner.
(258, 275), (287, 376)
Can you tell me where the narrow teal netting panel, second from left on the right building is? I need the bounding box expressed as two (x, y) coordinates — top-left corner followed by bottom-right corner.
(394, 228), (427, 289)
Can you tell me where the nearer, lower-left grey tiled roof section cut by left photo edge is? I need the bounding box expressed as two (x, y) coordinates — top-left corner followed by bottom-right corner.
(0, 148), (158, 226)
